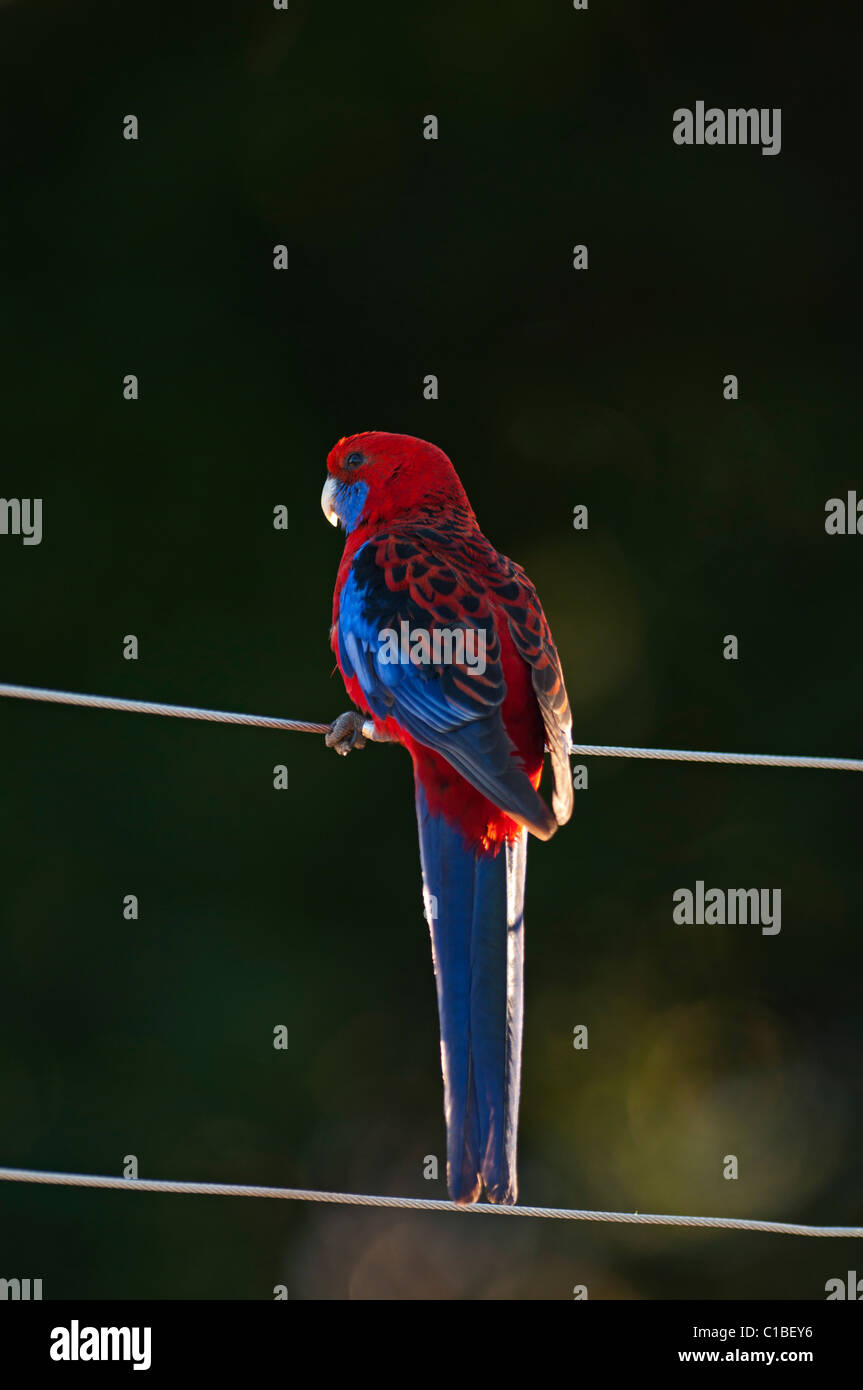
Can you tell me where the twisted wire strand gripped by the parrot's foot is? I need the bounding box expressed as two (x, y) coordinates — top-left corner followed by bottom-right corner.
(0, 684), (863, 773)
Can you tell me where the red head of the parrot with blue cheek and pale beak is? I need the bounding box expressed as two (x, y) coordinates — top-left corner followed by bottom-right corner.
(321, 430), (475, 531)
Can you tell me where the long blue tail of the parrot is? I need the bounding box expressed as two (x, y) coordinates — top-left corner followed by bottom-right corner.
(417, 785), (527, 1204)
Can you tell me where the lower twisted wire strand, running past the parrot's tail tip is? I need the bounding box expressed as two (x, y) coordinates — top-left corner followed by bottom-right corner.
(0, 1168), (863, 1240)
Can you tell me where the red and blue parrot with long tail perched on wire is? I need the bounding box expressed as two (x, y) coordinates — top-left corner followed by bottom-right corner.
(321, 431), (573, 1205)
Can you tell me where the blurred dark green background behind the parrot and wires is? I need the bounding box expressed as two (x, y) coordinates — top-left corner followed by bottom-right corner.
(0, 0), (863, 1300)
